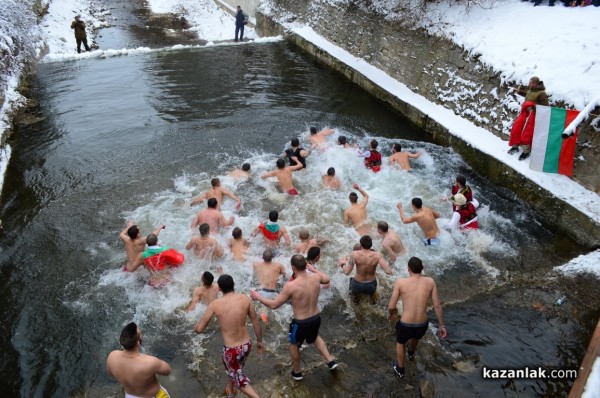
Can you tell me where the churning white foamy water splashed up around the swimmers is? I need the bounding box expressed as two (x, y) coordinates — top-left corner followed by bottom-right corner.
(91, 127), (513, 369)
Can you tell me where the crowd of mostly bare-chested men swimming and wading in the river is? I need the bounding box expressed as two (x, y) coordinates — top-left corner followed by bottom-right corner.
(107, 127), (478, 397)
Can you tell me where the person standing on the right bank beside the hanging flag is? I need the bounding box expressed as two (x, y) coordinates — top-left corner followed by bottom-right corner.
(508, 76), (549, 160)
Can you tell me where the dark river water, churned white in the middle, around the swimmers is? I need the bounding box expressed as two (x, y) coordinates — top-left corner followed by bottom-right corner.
(0, 4), (598, 397)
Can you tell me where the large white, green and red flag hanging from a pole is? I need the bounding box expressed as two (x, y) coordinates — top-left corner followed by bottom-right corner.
(529, 105), (579, 177)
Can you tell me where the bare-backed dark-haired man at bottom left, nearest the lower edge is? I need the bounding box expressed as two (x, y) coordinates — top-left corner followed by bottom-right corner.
(106, 322), (171, 398)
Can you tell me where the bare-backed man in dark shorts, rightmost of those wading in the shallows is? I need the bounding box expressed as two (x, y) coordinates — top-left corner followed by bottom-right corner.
(388, 257), (448, 379)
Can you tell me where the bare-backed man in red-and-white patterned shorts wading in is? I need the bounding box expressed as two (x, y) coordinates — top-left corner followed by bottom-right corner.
(194, 274), (263, 398)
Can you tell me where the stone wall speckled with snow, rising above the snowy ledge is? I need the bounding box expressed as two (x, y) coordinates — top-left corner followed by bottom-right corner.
(254, 0), (600, 193)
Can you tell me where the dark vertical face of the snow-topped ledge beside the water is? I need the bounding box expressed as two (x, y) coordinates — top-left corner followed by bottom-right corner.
(256, 13), (600, 249)
